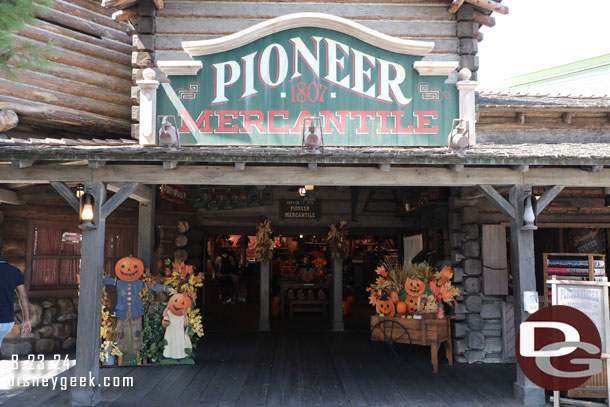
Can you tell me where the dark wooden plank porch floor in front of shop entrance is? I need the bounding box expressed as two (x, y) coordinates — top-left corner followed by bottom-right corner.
(2, 331), (521, 407)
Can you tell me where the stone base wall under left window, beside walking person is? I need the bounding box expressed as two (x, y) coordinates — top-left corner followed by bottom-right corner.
(0, 297), (78, 358)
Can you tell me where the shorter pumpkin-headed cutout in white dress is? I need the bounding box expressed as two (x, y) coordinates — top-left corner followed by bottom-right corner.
(163, 294), (193, 359)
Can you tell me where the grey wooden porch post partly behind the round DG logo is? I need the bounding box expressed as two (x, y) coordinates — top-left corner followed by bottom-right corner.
(509, 185), (545, 406)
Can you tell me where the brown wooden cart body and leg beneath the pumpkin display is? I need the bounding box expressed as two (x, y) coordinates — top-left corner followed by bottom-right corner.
(371, 315), (455, 373)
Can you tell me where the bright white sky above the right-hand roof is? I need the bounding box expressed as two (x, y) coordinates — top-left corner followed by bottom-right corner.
(478, 0), (610, 91)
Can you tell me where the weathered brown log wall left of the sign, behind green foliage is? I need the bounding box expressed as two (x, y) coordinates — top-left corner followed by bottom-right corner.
(0, 0), (132, 138)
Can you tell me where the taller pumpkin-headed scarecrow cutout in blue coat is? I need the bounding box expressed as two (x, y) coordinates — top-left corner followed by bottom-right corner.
(104, 256), (166, 360)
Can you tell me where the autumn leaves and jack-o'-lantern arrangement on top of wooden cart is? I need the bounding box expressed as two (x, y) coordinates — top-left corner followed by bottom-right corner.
(367, 262), (460, 318)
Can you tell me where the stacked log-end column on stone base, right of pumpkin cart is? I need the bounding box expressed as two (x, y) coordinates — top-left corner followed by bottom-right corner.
(449, 188), (503, 363)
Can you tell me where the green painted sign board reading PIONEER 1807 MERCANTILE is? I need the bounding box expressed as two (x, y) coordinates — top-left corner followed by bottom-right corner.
(157, 28), (458, 146)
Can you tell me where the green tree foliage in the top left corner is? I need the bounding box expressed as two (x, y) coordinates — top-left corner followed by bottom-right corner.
(0, 0), (56, 79)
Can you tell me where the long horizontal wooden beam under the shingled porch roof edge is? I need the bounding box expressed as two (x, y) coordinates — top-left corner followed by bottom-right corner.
(0, 164), (610, 188)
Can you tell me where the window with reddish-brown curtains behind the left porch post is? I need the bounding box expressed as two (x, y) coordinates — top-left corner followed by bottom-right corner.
(29, 222), (137, 292)
